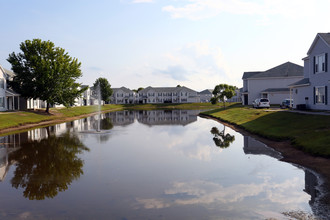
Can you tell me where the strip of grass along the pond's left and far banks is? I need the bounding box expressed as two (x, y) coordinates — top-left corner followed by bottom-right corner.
(0, 103), (219, 131)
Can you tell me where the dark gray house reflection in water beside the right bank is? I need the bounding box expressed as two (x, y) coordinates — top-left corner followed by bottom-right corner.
(243, 136), (282, 159)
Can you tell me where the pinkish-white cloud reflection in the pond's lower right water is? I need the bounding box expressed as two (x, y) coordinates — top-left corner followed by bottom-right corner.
(138, 178), (308, 209)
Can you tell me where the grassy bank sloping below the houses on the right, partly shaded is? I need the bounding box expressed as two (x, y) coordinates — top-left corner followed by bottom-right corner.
(203, 105), (330, 157)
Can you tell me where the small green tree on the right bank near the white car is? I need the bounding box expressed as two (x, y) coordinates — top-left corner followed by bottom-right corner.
(211, 84), (237, 108)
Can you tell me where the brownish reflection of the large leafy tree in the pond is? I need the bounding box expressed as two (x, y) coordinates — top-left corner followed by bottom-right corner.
(11, 133), (89, 200)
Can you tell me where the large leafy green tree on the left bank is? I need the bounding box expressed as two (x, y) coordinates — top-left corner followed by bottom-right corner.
(7, 39), (86, 113)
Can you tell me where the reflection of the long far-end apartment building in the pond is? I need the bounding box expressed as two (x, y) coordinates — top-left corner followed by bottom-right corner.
(137, 110), (199, 125)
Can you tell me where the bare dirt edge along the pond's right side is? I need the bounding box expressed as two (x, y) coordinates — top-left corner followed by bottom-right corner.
(201, 115), (330, 205)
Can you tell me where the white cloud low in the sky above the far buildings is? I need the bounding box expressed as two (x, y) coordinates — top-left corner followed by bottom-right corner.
(148, 41), (236, 90)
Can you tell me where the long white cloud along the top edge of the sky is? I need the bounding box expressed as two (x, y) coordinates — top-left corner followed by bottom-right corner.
(162, 0), (316, 20)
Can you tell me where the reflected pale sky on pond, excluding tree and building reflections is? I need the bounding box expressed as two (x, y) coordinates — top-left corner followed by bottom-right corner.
(0, 112), (318, 219)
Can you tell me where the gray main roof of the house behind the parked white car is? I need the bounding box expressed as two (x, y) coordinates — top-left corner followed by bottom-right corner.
(243, 62), (304, 79)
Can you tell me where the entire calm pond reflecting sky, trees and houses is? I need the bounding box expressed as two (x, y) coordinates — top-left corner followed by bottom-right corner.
(0, 110), (326, 220)
